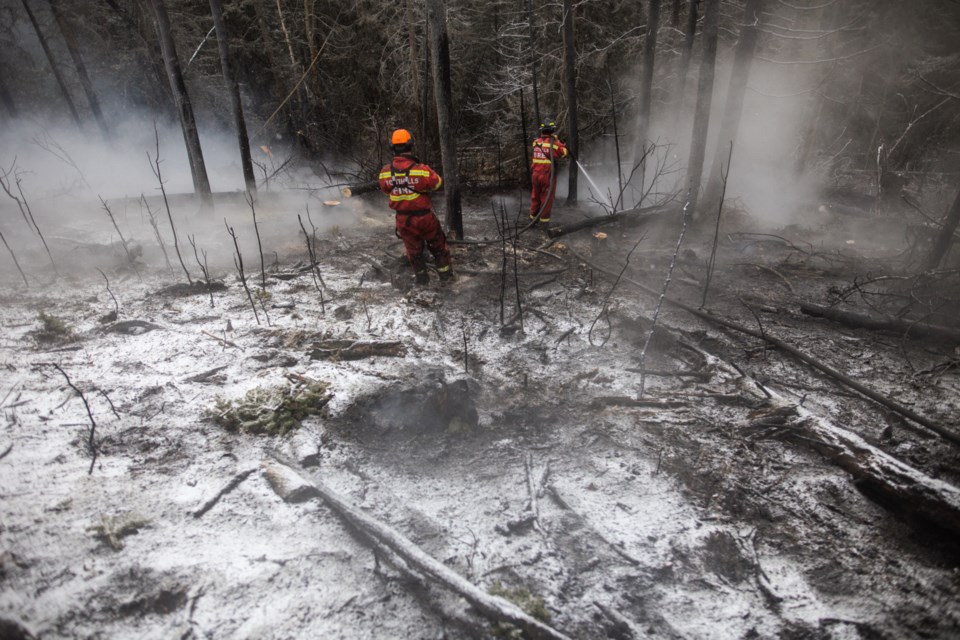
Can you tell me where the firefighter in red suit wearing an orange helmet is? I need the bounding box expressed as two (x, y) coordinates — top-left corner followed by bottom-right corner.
(379, 129), (453, 284)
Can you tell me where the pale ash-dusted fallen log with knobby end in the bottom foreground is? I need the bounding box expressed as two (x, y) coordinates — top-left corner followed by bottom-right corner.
(262, 460), (569, 640)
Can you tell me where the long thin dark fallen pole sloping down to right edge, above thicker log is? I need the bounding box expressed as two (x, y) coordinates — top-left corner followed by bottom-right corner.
(568, 247), (960, 446)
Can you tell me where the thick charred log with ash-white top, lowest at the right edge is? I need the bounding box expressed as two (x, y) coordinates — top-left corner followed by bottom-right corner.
(755, 390), (960, 535)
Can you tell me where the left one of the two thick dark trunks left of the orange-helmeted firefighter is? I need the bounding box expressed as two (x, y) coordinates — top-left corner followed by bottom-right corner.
(150, 0), (213, 206)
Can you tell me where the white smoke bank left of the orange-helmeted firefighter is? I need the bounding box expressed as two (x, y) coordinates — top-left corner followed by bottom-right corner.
(0, 118), (382, 280)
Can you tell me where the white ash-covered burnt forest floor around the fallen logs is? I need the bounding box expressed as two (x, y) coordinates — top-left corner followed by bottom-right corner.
(0, 191), (960, 639)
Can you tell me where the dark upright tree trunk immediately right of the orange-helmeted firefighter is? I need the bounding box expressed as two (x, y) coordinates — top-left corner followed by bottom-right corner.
(427, 0), (463, 238)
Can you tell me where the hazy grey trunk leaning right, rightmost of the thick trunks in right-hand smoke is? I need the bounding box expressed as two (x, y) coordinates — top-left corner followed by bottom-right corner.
(704, 0), (763, 206)
